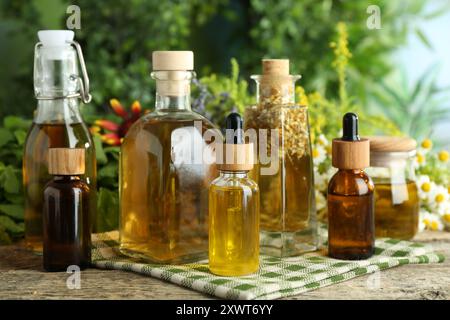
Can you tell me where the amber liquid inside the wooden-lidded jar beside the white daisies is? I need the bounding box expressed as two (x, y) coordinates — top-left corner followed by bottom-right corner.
(375, 179), (419, 239)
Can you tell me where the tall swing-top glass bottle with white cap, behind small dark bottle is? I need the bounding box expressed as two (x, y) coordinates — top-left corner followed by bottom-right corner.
(23, 30), (97, 252)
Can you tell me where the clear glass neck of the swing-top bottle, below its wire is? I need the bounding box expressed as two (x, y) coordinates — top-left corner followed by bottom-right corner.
(34, 98), (83, 123)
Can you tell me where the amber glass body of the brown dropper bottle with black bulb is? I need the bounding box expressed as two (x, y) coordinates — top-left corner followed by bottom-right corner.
(327, 170), (375, 260)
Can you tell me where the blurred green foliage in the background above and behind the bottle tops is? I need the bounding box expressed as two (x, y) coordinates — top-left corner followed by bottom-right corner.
(0, 0), (442, 122)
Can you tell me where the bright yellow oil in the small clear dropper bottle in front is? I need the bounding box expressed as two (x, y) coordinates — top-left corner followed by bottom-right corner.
(209, 177), (259, 276)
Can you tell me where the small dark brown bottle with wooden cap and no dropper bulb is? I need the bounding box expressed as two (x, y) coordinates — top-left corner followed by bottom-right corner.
(43, 148), (91, 271)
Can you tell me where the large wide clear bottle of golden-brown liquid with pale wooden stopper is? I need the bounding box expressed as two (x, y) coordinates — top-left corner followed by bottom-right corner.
(120, 51), (222, 263)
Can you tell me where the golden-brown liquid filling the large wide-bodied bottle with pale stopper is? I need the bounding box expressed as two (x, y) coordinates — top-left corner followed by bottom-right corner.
(120, 112), (218, 263)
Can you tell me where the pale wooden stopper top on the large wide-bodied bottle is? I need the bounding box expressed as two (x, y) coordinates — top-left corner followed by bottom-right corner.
(152, 51), (194, 71)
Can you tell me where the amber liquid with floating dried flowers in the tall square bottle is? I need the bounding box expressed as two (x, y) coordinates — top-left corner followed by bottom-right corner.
(245, 105), (317, 256)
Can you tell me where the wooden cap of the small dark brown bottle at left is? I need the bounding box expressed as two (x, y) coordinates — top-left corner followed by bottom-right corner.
(48, 148), (85, 176)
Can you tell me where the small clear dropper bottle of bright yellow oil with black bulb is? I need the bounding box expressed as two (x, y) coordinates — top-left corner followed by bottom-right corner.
(209, 113), (259, 276)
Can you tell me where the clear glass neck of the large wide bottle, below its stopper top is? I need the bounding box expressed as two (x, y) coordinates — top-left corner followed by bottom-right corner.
(152, 71), (195, 111)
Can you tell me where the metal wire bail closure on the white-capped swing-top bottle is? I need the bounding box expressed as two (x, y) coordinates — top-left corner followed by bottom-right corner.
(34, 41), (92, 103)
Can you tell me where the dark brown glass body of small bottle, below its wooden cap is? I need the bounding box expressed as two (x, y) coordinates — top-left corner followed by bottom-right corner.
(43, 176), (91, 271)
